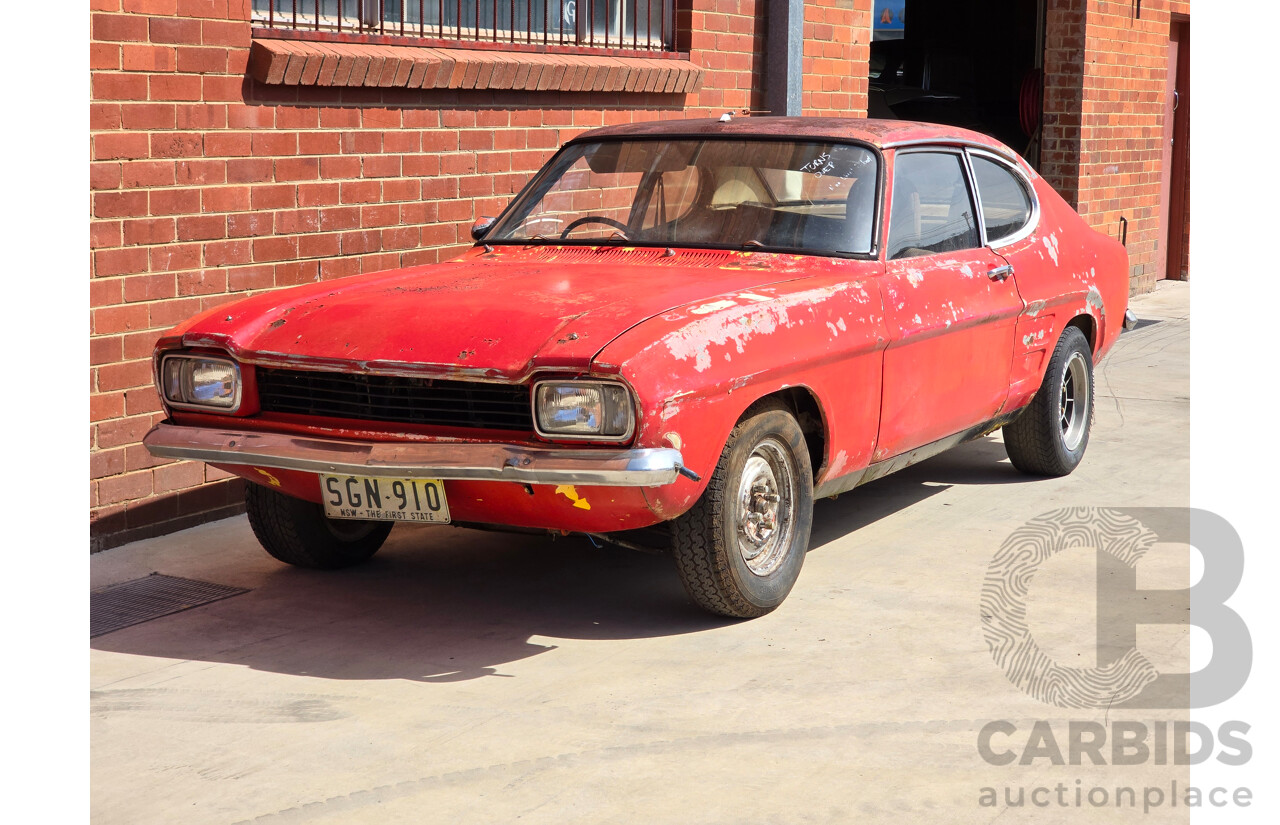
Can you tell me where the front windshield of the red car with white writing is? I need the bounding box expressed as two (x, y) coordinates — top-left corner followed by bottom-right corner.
(485, 138), (877, 253)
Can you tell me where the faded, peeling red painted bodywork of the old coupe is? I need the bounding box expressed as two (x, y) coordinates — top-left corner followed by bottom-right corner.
(149, 119), (1128, 532)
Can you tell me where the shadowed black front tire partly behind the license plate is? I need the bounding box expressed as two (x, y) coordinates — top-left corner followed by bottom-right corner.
(244, 483), (392, 570)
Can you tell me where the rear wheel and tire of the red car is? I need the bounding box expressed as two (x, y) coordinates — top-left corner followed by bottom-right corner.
(1005, 326), (1093, 476)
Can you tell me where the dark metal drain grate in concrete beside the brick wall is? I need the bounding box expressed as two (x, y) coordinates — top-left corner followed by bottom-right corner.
(88, 573), (248, 638)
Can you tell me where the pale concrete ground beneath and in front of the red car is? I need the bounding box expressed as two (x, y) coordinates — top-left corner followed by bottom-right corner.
(91, 283), (1189, 825)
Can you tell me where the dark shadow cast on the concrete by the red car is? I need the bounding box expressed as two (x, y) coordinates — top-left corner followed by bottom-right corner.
(91, 432), (1025, 683)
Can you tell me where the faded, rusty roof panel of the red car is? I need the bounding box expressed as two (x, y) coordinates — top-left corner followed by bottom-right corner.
(575, 116), (1014, 156)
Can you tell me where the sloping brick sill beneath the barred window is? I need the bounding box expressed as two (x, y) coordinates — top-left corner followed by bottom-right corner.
(248, 37), (703, 95)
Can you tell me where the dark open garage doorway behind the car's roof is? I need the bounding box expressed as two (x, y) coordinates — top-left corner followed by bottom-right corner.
(868, 0), (1046, 168)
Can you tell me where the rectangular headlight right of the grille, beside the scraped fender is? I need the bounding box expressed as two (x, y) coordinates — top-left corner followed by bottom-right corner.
(534, 381), (635, 441)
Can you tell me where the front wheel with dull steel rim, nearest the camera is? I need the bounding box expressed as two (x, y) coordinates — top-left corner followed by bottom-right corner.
(672, 403), (813, 619)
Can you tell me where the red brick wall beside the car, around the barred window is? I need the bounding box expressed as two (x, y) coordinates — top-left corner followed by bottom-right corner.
(90, 0), (870, 549)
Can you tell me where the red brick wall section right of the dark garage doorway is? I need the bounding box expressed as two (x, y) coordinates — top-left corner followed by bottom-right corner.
(1042, 0), (1190, 292)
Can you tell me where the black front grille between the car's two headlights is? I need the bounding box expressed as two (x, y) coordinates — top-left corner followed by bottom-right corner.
(257, 367), (534, 431)
